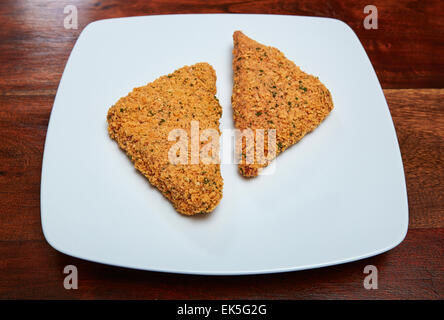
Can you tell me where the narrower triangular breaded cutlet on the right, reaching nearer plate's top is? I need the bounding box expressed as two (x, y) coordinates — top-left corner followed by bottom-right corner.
(232, 31), (333, 177)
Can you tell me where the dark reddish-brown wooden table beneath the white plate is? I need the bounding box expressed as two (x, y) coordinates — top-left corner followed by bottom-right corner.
(0, 0), (444, 299)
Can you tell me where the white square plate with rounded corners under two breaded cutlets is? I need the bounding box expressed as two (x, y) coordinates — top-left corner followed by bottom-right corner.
(41, 14), (408, 275)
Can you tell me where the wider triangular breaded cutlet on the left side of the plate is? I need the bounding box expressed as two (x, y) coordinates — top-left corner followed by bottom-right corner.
(107, 63), (223, 215)
